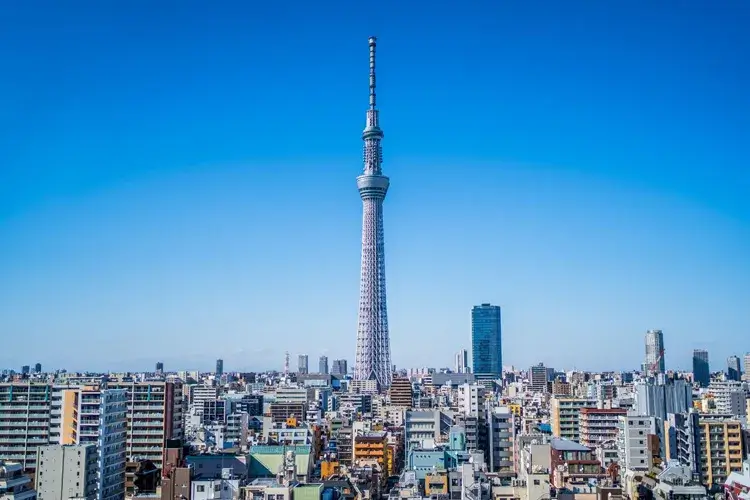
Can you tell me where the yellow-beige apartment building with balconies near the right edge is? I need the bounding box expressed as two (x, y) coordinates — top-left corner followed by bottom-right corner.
(698, 415), (742, 485)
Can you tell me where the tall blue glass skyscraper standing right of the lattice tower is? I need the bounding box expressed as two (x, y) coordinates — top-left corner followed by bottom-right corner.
(471, 304), (503, 379)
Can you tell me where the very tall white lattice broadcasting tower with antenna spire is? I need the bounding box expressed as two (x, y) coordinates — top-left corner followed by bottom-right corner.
(354, 37), (391, 389)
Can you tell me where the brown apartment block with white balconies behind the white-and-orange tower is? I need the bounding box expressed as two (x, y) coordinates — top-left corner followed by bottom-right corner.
(107, 380), (183, 469)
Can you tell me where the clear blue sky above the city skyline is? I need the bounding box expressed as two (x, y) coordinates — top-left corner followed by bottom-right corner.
(0, 0), (750, 376)
